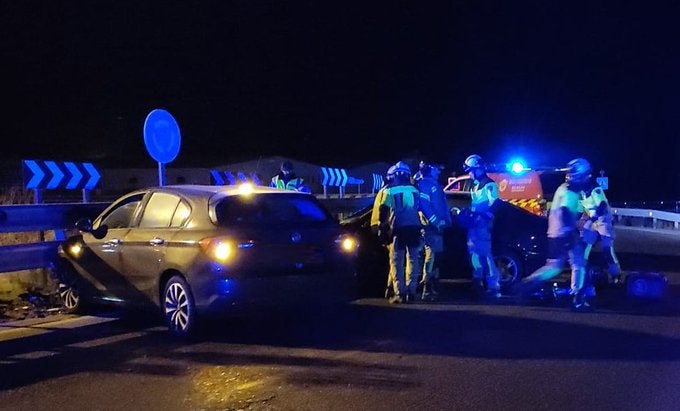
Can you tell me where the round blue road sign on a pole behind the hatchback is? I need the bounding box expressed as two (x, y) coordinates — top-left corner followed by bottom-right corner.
(144, 109), (182, 163)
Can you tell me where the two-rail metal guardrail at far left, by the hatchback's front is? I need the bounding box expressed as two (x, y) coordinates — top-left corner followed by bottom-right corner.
(0, 203), (109, 273)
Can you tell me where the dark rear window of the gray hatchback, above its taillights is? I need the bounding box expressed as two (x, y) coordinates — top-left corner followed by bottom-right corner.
(215, 194), (331, 226)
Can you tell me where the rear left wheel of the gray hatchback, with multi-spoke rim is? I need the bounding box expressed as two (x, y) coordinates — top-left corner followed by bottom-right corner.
(161, 275), (196, 337)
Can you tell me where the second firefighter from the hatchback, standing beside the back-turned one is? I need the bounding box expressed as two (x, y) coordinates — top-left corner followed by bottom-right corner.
(417, 162), (451, 301)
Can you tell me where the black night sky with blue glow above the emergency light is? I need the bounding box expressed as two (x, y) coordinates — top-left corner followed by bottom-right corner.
(0, 0), (680, 199)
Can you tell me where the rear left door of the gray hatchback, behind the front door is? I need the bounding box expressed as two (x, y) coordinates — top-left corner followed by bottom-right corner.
(122, 191), (188, 300)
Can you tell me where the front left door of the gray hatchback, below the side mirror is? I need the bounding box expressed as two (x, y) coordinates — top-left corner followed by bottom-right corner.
(79, 192), (145, 299)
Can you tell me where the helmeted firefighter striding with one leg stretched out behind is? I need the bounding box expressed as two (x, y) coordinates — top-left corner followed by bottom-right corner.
(520, 158), (591, 311)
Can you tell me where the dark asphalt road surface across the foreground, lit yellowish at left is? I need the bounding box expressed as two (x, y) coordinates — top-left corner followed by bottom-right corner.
(0, 229), (680, 410)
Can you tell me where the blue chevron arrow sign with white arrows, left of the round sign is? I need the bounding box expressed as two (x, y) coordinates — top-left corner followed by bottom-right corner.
(22, 160), (101, 190)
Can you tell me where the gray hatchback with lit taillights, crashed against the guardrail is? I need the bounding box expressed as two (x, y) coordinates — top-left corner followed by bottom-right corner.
(57, 185), (357, 335)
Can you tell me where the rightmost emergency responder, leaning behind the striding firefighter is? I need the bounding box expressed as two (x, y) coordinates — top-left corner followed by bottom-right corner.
(581, 171), (621, 286)
